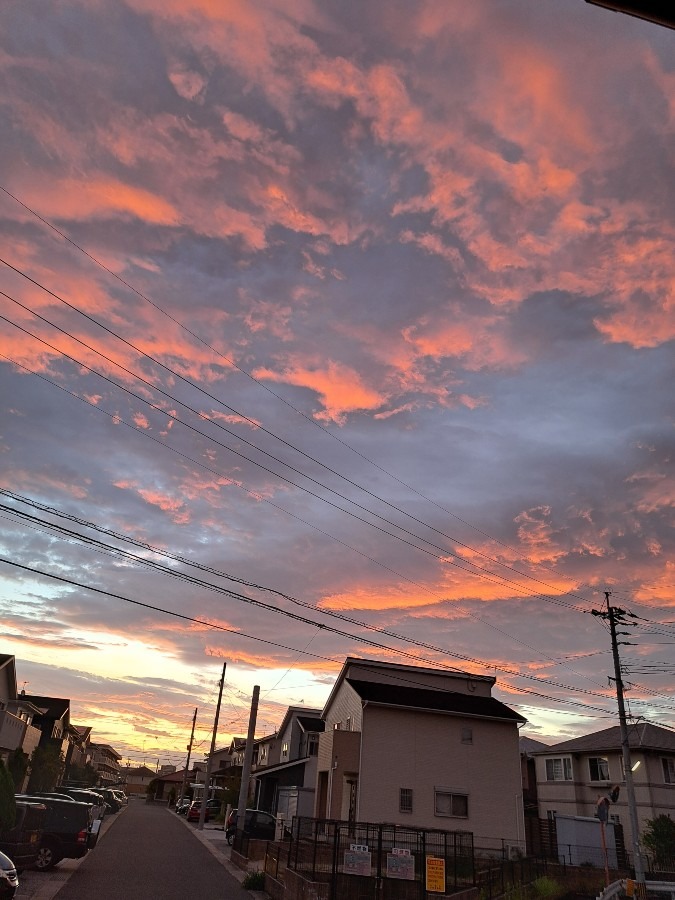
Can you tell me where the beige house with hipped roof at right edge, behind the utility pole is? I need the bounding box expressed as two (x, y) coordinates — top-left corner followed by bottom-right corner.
(534, 722), (675, 847)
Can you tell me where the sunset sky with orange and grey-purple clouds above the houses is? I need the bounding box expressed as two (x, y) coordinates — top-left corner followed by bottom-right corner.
(0, 0), (675, 765)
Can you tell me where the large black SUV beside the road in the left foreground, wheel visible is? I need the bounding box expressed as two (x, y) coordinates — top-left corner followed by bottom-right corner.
(17, 794), (100, 871)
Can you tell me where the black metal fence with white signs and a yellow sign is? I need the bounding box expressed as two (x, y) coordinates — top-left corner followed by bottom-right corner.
(286, 817), (475, 900)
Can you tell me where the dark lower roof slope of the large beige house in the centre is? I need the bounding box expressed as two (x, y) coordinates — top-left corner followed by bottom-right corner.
(345, 678), (527, 722)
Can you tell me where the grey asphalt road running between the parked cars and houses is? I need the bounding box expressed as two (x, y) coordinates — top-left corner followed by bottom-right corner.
(17, 802), (251, 900)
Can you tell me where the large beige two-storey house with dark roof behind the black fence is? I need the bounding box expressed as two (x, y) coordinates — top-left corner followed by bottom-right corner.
(315, 657), (526, 850)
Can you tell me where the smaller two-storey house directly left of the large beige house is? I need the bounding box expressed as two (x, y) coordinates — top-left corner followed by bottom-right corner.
(255, 706), (325, 821)
